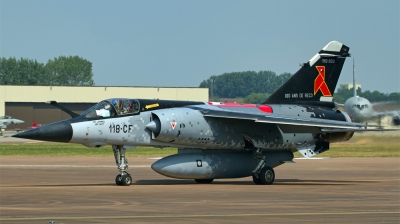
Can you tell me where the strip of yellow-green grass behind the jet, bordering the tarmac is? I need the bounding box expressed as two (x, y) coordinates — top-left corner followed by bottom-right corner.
(0, 136), (400, 157)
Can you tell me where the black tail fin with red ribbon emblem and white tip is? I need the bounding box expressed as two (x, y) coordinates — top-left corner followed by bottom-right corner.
(263, 41), (350, 104)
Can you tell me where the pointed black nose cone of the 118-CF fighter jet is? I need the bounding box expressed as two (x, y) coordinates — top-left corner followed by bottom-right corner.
(12, 121), (72, 142)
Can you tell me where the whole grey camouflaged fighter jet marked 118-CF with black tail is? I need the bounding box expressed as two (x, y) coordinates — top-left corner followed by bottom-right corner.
(14, 41), (367, 185)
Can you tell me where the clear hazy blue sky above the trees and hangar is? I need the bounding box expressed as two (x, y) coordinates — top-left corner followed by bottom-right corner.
(0, 0), (400, 93)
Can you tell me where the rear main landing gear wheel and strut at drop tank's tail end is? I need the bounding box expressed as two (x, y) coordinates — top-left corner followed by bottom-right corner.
(252, 149), (275, 185)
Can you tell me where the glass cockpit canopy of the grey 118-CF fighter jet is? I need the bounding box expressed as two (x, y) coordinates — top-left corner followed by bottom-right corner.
(81, 98), (140, 118)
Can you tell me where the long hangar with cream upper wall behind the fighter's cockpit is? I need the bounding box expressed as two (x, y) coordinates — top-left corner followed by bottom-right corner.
(0, 85), (208, 130)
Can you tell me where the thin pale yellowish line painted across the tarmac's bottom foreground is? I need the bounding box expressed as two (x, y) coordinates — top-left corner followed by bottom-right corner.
(0, 211), (400, 221)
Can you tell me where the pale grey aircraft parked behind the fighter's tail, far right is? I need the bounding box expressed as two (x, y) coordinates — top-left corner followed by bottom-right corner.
(344, 58), (400, 125)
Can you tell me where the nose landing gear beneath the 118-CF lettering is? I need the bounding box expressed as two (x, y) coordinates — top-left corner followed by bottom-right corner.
(112, 145), (132, 186)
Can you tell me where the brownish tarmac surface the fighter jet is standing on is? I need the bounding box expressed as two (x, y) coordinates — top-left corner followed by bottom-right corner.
(0, 156), (400, 223)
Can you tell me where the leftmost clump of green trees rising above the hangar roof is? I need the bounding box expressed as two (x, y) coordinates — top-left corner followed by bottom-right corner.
(0, 56), (94, 86)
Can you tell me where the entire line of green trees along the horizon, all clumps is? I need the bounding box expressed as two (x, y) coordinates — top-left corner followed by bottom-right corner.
(0, 56), (400, 103)
